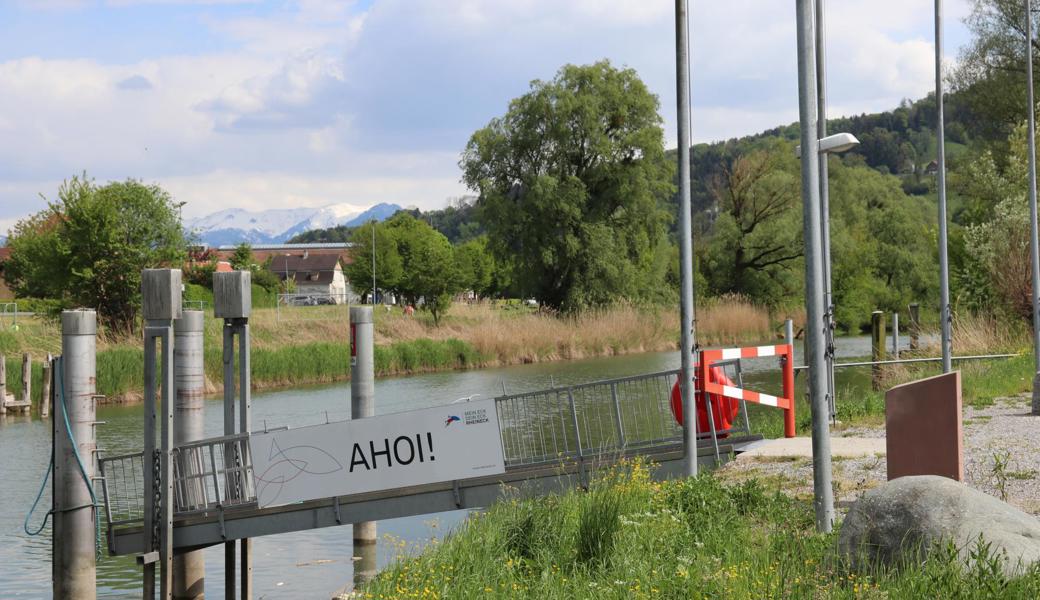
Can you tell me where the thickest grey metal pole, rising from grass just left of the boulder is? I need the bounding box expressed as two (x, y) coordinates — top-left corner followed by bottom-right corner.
(795, 0), (834, 532)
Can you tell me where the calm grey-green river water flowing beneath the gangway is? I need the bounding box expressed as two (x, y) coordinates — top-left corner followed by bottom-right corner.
(0, 337), (906, 598)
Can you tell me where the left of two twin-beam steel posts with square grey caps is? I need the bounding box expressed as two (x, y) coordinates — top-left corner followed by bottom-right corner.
(140, 268), (181, 600)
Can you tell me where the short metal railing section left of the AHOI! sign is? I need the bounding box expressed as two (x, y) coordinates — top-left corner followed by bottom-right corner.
(98, 434), (256, 529)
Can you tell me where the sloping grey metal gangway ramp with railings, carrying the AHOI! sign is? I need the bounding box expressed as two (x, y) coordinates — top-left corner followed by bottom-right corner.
(99, 361), (761, 555)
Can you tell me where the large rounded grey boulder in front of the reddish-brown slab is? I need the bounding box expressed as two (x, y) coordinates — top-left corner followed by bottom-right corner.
(838, 475), (1040, 576)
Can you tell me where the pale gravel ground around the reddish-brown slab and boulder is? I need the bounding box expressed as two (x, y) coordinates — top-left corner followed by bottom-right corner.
(719, 395), (1040, 515)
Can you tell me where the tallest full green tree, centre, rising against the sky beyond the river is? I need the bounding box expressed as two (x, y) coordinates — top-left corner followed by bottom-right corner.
(460, 60), (674, 310)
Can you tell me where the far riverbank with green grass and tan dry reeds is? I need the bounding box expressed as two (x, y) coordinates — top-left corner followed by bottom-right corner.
(0, 298), (776, 405)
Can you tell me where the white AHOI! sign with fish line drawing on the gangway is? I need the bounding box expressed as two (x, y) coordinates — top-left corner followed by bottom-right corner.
(250, 400), (505, 507)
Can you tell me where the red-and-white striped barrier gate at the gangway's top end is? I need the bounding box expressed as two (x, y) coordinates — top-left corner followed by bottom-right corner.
(697, 344), (796, 438)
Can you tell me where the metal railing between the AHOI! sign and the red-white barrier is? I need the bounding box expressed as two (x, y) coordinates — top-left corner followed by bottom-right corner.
(495, 360), (751, 466)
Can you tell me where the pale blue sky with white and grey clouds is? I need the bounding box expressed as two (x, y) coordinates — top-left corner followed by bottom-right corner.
(0, 0), (970, 234)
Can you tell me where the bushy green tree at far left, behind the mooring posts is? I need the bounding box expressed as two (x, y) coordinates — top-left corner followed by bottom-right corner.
(4, 176), (187, 330)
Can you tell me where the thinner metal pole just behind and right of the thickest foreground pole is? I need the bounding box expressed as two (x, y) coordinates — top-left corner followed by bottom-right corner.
(815, 0), (837, 420)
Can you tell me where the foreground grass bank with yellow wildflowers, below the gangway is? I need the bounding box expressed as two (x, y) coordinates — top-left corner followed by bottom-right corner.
(361, 463), (1040, 600)
